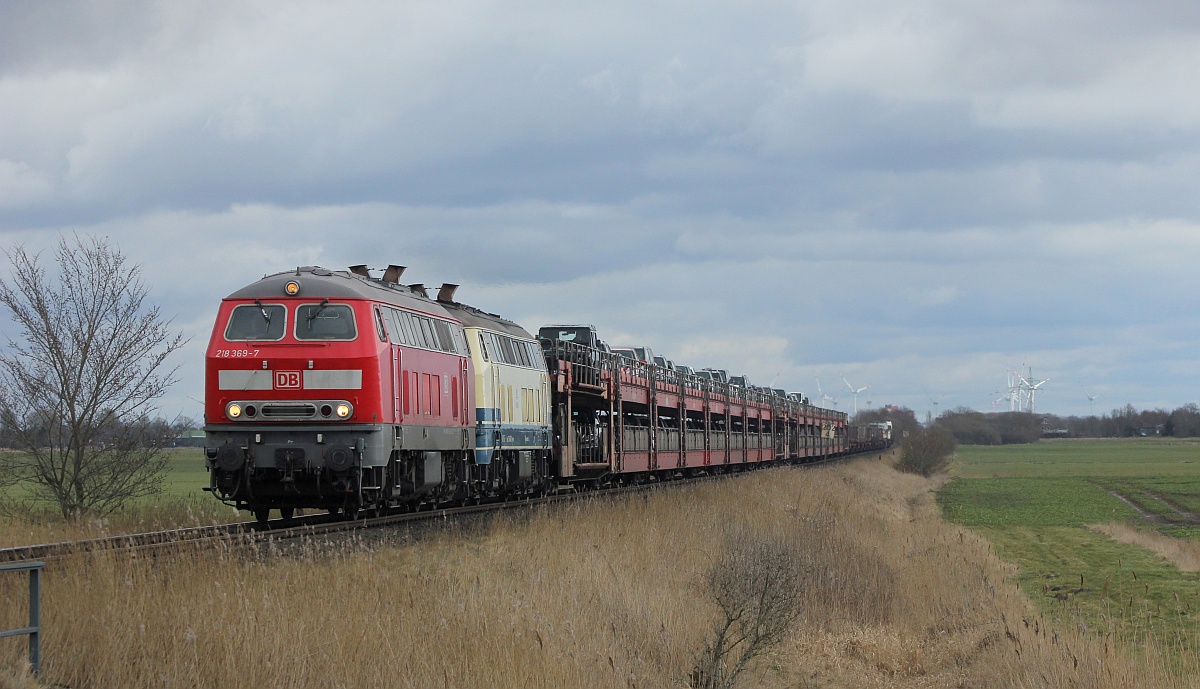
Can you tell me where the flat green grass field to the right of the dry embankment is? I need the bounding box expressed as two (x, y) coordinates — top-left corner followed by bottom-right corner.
(938, 438), (1200, 648)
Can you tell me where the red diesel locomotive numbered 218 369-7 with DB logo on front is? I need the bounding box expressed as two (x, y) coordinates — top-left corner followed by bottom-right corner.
(204, 266), (475, 521)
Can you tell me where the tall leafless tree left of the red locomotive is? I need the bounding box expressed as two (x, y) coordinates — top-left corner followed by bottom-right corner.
(0, 235), (185, 520)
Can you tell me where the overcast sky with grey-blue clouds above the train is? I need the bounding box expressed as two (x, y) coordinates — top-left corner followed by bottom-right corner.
(0, 0), (1200, 418)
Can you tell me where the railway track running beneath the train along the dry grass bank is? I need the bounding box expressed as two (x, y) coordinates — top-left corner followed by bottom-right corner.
(0, 450), (875, 563)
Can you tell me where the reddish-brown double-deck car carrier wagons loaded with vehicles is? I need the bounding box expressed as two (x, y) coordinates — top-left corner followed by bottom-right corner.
(541, 338), (851, 481)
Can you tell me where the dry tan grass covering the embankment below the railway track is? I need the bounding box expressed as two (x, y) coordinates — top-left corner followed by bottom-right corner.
(0, 453), (1196, 688)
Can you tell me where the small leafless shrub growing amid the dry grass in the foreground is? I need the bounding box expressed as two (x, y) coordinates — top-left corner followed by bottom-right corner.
(691, 528), (804, 689)
